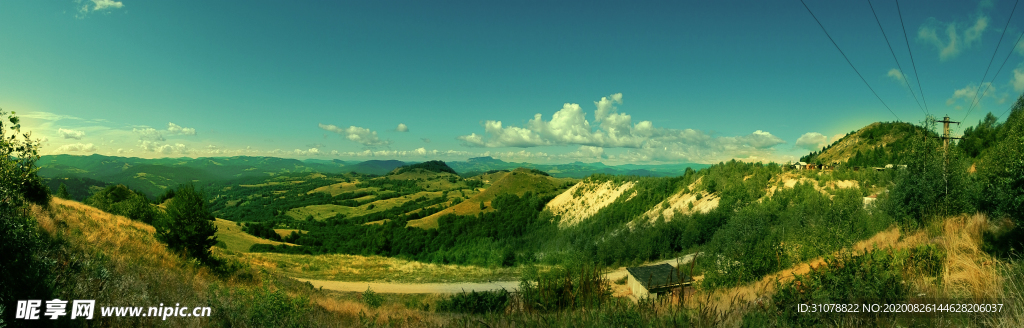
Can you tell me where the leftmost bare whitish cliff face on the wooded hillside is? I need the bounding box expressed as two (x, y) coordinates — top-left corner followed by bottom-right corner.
(545, 180), (636, 228)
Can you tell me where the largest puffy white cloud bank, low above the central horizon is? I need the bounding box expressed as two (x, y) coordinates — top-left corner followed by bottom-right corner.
(457, 93), (785, 161)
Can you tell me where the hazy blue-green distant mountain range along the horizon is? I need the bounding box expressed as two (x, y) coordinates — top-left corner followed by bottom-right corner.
(37, 155), (710, 198)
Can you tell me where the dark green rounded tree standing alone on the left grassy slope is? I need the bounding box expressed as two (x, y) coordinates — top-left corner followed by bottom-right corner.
(157, 183), (217, 262)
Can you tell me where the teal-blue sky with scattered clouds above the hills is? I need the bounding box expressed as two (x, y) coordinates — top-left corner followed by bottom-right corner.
(0, 0), (1024, 164)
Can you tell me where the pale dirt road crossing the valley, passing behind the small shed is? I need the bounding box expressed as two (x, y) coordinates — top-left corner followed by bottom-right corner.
(292, 254), (694, 294)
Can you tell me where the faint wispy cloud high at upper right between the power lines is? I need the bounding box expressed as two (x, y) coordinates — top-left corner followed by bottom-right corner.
(918, 14), (988, 60)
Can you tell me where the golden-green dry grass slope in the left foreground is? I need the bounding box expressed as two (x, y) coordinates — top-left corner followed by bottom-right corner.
(22, 198), (441, 327)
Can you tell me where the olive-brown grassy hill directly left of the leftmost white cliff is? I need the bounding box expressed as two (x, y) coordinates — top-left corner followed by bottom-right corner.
(408, 168), (571, 229)
